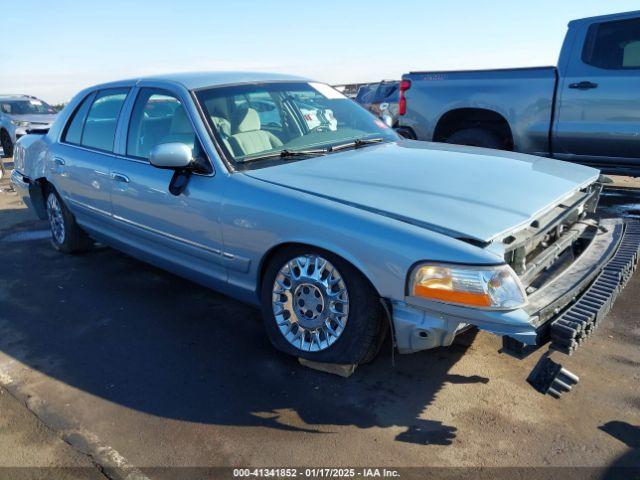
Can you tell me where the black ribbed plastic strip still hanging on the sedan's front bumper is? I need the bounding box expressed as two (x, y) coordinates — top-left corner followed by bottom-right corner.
(550, 222), (640, 356)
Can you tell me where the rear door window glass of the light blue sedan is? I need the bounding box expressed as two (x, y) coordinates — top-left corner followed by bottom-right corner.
(80, 88), (128, 152)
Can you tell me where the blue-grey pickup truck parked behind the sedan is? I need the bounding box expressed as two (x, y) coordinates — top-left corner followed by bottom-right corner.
(399, 11), (640, 176)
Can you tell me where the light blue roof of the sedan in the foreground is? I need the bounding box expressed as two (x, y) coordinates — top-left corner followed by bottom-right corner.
(92, 71), (309, 90)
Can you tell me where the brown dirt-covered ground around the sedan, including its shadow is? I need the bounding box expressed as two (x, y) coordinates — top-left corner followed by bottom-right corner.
(0, 162), (640, 479)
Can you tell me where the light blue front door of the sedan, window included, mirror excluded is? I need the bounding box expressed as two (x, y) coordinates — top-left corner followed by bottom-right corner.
(111, 88), (226, 288)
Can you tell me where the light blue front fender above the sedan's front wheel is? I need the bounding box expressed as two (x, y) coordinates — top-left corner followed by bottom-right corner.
(221, 174), (501, 300)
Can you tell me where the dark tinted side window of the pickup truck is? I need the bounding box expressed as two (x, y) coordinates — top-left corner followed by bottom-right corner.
(582, 18), (640, 70)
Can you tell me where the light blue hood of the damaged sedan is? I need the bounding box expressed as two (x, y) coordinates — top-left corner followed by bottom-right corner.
(246, 140), (600, 242)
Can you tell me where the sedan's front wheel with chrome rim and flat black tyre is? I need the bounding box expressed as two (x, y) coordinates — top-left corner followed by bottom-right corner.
(261, 247), (386, 364)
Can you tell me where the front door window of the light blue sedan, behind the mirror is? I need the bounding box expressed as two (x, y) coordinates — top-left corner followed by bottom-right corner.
(127, 88), (196, 160)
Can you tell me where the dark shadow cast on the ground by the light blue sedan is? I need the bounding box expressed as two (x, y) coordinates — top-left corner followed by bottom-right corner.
(0, 236), (489, 445)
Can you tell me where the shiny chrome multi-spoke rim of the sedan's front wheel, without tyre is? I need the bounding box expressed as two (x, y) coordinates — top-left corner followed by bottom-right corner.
(271, 255), (349, 352)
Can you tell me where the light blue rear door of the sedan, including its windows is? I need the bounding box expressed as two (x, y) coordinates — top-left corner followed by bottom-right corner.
(47, 88), (129, 231)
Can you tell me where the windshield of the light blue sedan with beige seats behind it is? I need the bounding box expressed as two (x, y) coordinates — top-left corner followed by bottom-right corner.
(196, 82), (398, 163)
